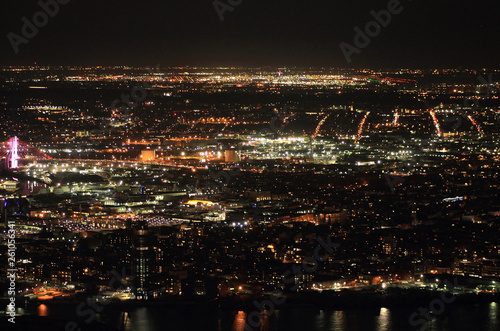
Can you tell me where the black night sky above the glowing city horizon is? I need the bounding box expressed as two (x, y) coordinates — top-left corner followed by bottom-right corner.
(0, 0), (500, 68)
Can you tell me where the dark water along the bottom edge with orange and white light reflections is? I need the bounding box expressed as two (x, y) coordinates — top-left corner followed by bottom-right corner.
(20, 302), (500, 331)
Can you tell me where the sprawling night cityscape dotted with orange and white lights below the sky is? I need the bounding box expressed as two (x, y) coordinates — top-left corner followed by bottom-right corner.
(0, 66), (500, 331)
